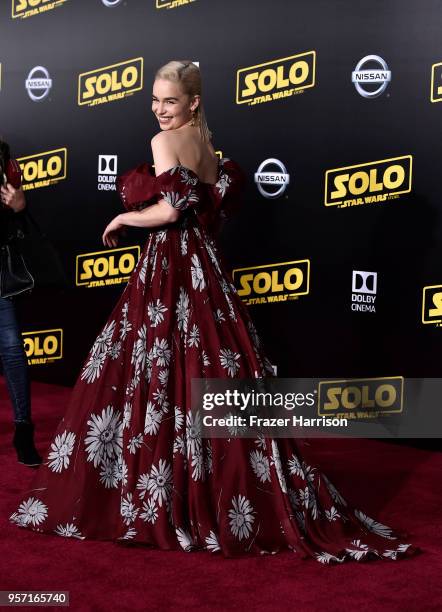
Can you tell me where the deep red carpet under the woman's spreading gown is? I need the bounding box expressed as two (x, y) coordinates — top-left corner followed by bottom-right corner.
(0, 378), (442, 612)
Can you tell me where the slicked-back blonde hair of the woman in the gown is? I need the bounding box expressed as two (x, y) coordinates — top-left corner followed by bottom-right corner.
(155, 60), (212, 142)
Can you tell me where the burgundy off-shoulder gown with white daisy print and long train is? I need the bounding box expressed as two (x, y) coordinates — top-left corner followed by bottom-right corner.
(10, 158), (420, 563)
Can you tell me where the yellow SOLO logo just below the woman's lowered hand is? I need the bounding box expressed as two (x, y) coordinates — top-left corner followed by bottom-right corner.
(76, 245), (140, 288)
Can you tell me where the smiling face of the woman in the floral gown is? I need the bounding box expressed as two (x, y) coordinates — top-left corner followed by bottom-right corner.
(152, 79), (199, 130)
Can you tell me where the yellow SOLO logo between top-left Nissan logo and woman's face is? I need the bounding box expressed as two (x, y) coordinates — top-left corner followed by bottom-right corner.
(78, 57), (143, 106)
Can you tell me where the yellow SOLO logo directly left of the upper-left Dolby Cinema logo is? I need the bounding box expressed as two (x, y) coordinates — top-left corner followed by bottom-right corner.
(18, 148), (68, 190)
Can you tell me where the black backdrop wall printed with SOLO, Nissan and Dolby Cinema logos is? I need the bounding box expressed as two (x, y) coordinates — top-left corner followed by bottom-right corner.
(0, 0), (442, 412)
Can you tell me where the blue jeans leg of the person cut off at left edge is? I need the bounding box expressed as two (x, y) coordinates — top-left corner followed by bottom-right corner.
(0, 298), (31, 422)
